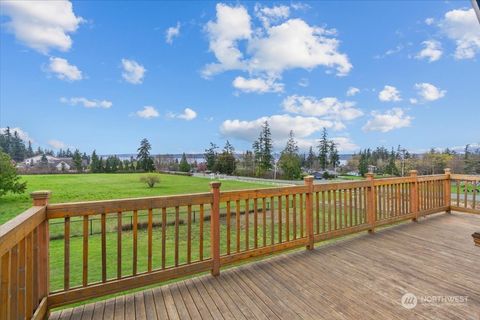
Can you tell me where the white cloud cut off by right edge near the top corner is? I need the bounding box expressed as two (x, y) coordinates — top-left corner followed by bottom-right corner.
(439, 8), (480, 59)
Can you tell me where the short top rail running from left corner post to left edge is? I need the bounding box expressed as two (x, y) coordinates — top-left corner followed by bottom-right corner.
(0, 206), (46, 257)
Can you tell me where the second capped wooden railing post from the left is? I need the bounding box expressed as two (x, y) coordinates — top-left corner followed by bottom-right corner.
(210, 182), (221, 276)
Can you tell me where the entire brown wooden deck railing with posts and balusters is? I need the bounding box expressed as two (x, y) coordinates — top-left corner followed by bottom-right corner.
(0, 169), (480, 320)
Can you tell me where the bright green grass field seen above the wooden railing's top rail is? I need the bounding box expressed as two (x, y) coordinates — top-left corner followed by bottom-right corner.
(0, 173), (268, 225)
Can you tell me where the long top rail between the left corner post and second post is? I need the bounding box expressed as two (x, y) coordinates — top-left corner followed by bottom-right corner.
(47, 192), (213, 219)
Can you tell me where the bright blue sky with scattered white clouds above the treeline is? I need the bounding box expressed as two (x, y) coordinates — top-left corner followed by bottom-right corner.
(0, 1), (480, 154)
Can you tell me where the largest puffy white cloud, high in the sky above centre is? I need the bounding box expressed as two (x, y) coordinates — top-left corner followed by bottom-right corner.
(203, 4), (352, 78)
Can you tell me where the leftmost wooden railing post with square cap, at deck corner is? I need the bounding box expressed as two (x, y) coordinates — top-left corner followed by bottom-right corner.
(30, 190), (51, 302)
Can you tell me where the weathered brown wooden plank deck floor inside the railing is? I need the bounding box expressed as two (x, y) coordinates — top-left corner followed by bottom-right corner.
(50, 213), (480, 320)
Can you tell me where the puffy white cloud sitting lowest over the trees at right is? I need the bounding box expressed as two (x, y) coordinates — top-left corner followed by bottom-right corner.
(362, 108), (413, 132)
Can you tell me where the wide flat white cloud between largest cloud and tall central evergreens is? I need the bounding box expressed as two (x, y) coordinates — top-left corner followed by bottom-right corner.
(282, 95), (363, 121)
